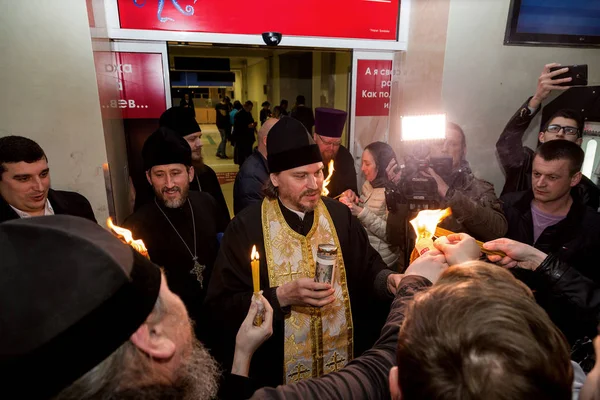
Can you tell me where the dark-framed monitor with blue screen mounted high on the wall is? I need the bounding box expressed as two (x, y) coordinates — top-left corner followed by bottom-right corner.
(504, 0), (600, 47)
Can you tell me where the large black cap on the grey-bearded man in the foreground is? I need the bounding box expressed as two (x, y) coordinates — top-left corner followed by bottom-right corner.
(0, 215), (161, 399)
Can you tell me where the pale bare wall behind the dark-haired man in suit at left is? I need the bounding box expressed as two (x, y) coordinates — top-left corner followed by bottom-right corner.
(0, 0), (108, 221)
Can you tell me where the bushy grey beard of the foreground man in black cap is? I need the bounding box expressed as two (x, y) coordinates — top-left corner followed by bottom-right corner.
(111, 339), (220, 400)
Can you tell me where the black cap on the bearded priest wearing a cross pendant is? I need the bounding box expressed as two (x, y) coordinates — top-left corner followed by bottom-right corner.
(142, 127), (192, 171)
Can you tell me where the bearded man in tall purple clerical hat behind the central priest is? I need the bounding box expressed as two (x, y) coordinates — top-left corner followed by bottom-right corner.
(313, 107), (358, 198)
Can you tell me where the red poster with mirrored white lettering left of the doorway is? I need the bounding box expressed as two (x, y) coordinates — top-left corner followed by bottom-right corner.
(94, 52), (166, 119)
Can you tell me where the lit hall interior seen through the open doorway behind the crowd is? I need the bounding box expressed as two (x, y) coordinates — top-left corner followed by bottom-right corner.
(168, 42), (352, 216)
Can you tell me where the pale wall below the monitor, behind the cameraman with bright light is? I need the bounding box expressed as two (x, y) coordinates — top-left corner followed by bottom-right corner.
(442, 0), (600, 193)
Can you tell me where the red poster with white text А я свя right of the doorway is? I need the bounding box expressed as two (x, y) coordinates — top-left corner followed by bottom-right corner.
(356, 60), (392, 117)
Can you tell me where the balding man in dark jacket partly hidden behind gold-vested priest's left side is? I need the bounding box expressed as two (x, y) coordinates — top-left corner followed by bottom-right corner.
(233, 118), (278, 215)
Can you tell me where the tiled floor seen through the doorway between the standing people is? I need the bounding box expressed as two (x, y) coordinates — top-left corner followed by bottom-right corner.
(200, 125), (239, 217)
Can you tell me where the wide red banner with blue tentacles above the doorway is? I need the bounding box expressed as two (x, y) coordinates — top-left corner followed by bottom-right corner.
(117, 0), (400, 40)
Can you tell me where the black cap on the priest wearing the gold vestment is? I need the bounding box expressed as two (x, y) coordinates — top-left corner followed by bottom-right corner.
(267, 117), (323, 173)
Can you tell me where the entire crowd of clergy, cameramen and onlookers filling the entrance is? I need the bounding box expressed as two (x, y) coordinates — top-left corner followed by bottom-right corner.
(0, 64), (600, 400)
